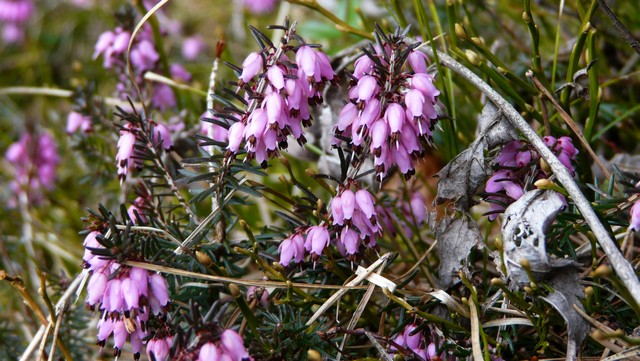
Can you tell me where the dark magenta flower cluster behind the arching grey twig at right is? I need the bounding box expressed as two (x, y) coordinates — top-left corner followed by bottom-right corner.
(485, 136), (578, 220)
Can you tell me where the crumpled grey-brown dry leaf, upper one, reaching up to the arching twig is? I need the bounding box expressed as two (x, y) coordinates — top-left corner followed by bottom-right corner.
(436, 102), (518, 210)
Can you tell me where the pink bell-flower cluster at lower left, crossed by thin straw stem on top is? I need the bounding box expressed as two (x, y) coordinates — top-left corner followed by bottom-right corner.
(82, 231), (169, 359)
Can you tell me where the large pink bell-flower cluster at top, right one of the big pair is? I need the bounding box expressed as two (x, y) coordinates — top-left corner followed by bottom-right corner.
(334, 35), (440, 180)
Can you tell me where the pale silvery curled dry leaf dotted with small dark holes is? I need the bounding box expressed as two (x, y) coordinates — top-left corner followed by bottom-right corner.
(502, 190), (575, 285)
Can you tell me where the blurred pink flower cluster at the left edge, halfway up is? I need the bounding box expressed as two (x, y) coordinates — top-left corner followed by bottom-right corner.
(5, 133), (60, 205)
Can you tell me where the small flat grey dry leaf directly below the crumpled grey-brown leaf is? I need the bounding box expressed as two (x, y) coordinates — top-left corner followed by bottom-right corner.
(434, 213), (482, 288)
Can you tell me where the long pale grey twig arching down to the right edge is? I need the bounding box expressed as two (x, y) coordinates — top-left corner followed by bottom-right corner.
(424, 48), (640, 305)
